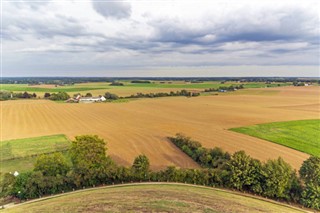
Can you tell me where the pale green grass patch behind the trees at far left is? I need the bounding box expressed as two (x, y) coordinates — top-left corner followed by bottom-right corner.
(0, 135), (70, 173)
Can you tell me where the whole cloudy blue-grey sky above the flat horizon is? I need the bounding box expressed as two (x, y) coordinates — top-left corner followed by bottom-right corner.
(1, 0), (320, 77)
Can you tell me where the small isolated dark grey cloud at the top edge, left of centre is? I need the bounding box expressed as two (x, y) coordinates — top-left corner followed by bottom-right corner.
(92, 0), (131, 19)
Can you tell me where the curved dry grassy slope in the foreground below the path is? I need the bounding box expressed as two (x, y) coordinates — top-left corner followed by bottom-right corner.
(3, 183), (304, 213)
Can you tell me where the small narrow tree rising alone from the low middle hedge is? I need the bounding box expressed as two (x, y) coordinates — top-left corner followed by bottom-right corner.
(132, 155), (150, 179)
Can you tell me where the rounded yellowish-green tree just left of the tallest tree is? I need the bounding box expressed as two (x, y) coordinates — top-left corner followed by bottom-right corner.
(34, 152), (70, 176)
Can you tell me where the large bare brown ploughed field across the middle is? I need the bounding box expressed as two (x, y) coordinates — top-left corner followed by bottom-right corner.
(1, 87), (320, 169)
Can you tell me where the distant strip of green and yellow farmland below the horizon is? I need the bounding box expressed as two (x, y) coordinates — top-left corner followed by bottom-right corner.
(1, 81), (291, 97)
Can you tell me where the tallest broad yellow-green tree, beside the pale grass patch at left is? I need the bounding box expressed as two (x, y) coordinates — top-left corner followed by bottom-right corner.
(69, 135), (111, 186)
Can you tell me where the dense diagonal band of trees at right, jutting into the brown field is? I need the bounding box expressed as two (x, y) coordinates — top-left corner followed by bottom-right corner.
(169, 134), (320, 209)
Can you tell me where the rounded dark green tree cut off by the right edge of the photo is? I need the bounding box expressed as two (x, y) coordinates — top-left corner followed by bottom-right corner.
(299, 156), (320, 186)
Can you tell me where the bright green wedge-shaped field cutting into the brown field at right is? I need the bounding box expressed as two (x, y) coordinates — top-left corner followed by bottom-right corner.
(230, 120), (320, 157)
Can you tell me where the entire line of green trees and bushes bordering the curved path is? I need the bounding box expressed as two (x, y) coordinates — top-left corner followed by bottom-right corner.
(0, 135), (320, 209)
